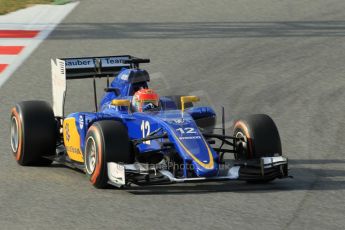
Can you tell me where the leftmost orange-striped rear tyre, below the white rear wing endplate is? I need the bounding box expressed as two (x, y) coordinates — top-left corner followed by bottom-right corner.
(11, 101), (57, 166)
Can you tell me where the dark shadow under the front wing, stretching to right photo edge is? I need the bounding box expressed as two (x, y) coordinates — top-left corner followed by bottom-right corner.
(125, 159), (345, 195)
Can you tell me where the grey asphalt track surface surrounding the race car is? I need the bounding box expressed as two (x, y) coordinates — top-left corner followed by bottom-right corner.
(0, 0), (345, 229)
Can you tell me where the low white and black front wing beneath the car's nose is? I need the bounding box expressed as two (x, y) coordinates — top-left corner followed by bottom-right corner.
(107, 156), (288, 187)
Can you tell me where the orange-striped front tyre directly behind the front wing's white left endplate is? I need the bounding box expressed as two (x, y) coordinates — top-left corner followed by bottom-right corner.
(84, 120), (134, 188)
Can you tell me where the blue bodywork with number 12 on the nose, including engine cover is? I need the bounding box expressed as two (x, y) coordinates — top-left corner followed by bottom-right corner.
(67, 69), (219, 177)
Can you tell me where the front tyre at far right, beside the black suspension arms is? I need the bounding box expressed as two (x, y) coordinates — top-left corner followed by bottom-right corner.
(233, 114), (282, 160)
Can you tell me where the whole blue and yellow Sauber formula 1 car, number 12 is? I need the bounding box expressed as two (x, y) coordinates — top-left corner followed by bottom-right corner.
(11, 55), (288, 188)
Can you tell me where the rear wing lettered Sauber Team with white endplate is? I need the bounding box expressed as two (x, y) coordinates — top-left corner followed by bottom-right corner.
(51, 55), (150, 117)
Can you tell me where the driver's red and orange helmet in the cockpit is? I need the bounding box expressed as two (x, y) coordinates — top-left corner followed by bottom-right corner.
(132, 89), (159, 112)
